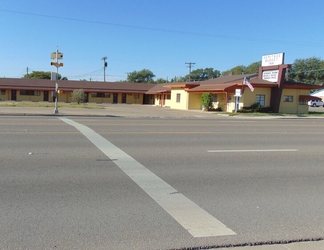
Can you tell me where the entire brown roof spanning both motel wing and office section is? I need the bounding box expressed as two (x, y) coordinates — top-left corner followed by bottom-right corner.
(0, 74), (316, 94)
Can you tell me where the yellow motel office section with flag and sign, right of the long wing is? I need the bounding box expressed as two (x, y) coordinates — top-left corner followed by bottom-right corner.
(147, 53), (322, 114)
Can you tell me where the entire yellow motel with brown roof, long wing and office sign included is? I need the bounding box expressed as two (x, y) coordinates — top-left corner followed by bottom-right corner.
(0, 53), (322, 114)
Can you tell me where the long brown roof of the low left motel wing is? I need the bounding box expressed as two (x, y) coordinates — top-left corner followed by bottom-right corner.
(0, 78), (155, 93)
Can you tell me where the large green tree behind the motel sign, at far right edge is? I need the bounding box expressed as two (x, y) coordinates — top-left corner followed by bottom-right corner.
(288, 57), (324, 85)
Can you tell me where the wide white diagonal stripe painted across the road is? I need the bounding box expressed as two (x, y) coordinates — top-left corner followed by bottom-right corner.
(59, 117), (236, 237)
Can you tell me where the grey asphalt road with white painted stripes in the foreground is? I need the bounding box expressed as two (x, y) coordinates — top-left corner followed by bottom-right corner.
(0, 116), (324, 250)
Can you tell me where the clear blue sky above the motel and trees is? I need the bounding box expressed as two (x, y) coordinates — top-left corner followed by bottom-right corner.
(0, 0), (324, 81)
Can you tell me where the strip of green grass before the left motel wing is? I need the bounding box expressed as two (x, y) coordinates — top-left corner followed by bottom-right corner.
(0, 101), (103, 109)
